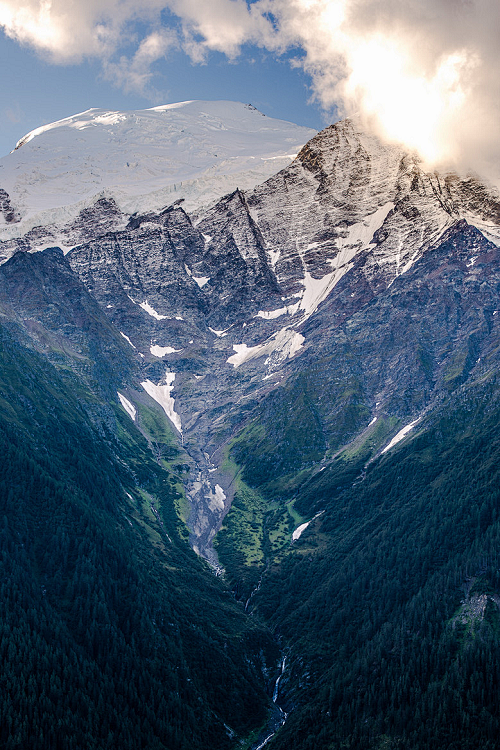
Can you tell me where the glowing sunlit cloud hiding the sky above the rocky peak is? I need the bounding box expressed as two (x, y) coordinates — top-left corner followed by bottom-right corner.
(273, 0), (500, 179)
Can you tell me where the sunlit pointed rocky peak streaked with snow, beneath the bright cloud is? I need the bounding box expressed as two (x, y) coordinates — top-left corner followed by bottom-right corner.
(248, 120), (500, 290)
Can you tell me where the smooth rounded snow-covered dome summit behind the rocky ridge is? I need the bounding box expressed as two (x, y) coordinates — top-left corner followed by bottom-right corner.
(0, 101), (316, 238)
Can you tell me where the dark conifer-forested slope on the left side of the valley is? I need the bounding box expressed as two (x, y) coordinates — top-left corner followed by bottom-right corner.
(0, 328), (276, 750)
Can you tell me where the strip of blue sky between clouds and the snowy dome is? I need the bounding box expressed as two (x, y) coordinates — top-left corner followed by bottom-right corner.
(0, 32), (330, 156)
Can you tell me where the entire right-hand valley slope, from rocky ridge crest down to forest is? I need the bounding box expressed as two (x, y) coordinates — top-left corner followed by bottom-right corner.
(216, 224), (500, 750)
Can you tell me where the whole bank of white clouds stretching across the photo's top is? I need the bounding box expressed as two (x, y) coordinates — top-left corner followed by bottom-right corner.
(0, 0), (500, 181)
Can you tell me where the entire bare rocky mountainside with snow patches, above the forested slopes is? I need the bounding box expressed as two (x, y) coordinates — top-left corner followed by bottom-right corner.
(0, 120), (500, 564)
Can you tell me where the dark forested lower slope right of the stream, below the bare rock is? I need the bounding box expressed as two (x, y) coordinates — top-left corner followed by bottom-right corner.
(253, 379), (500, 750)
